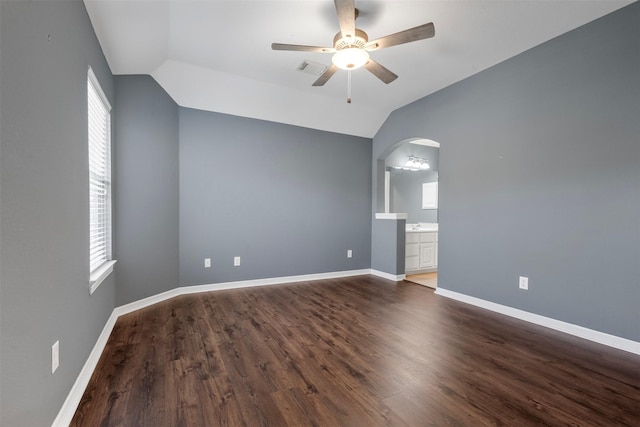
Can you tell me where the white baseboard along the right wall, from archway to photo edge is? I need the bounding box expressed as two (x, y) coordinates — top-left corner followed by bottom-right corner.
(435, 288), (640, 355)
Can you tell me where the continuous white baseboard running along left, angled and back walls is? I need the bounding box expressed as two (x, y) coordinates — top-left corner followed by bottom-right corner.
(52, 268), (372, 427)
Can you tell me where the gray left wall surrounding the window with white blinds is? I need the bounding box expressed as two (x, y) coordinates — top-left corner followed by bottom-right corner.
(0, 0), (117, 427)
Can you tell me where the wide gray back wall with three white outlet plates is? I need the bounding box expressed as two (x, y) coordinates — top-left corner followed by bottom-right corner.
(180, 108), (371, 285)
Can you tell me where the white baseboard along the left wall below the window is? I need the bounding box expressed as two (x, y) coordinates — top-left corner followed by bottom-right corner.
(51, 310), (119, 427)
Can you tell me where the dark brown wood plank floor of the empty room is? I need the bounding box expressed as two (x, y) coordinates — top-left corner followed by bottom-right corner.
(71, 276), (640, 427)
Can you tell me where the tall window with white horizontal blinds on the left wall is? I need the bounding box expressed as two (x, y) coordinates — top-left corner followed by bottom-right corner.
(87, 68), (115, 293)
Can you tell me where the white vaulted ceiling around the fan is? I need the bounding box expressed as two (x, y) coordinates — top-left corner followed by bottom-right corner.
(84, 0), (633, 137)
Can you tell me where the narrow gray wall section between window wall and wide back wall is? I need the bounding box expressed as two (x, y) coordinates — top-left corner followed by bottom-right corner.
(113, 76), (179, 305)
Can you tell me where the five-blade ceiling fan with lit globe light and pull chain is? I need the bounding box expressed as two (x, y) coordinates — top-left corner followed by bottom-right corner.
(271, 0), (435, 103)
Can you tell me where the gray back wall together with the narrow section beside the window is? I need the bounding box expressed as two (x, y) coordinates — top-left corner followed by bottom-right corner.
(114, 83), (371, 305)
